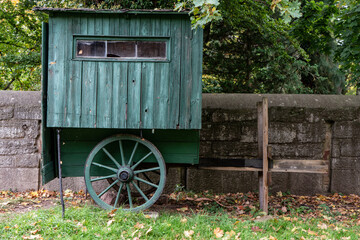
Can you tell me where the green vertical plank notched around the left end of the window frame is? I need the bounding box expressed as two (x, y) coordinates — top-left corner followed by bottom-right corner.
(65, 17), (81, 127)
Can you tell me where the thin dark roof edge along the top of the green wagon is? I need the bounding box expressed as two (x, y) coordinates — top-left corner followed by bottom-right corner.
(33, 7), (189, 14)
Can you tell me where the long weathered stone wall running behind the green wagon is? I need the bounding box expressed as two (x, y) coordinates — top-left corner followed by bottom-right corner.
(0, 91), (360, 194)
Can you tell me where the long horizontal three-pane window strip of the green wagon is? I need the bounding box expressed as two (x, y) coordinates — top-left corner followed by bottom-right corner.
(76, 40), (167, 60)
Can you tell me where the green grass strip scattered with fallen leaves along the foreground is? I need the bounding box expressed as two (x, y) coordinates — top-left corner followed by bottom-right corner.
(0, 205), (360, 239)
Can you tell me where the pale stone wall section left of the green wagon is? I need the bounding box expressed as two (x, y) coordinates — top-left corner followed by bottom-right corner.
(0, 91), (41, 191)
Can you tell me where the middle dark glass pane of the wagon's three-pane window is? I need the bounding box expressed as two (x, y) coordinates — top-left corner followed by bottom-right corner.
(106, 41), (136, 57)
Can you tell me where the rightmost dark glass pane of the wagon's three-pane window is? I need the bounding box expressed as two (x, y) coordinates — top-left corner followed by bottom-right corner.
(137, 41), (166, 58)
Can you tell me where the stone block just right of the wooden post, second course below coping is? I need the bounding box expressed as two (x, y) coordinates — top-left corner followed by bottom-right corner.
(269, 122), (296, 143)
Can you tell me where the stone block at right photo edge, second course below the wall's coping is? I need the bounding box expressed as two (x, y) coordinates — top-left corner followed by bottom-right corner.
(333, 120), (360, 138)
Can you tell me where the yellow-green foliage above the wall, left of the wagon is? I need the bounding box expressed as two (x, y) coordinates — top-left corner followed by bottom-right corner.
(0, 0), (46, 90)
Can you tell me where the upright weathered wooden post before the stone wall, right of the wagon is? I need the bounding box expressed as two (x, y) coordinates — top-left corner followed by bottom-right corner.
(257, 98), (269, 213)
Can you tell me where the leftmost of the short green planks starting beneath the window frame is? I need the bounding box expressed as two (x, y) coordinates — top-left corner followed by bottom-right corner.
(81, 62), (98, 128)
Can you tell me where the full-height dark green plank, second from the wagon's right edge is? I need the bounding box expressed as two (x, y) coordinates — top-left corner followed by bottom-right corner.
(179, 18), (193, 129)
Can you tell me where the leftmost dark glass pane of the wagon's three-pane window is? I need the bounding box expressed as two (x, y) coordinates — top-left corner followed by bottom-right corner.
(76, 40), (105, 57)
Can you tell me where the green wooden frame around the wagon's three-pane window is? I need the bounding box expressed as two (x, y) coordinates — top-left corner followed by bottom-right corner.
(72, 35), (171, 62)
